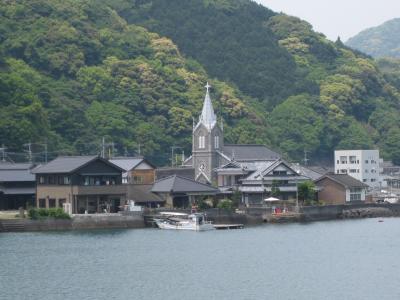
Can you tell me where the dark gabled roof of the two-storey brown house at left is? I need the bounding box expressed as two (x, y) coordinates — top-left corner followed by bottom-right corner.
(32, 155), (124, 174)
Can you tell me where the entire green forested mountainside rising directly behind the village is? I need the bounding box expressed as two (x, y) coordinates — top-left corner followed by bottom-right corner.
(0, 0), (400, 163)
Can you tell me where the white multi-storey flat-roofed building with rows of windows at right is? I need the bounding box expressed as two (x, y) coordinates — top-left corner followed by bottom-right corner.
(335, 150), (383, 188)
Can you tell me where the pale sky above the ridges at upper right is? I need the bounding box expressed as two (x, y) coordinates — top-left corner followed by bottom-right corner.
(255, 0), (400, 42)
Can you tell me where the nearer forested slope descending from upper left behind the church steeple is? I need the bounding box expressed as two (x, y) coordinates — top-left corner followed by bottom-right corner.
(0, 0), (268, 164)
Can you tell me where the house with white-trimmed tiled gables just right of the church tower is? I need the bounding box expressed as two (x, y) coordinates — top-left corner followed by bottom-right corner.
(216, 159), (310, 205)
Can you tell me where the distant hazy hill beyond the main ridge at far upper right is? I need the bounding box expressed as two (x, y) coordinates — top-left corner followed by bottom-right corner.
(346, 19), (400, 58)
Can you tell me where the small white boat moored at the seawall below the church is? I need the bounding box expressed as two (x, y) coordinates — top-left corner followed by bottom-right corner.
(154, 213), (215, 231)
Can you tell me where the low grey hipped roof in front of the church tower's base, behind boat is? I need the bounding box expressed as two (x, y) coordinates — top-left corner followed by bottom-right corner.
(151, 175), (218, 194)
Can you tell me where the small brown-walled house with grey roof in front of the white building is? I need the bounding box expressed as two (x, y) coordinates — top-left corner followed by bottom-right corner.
(315, 173), (368, 205)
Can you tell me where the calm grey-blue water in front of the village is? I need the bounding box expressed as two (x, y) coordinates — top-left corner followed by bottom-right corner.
(0, 219), (400, 300)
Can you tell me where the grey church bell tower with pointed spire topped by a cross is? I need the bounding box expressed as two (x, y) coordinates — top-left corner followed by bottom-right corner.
(192, 82), (224, 184)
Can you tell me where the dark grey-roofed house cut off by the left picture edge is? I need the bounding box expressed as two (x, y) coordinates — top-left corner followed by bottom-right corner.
(0, 162), (36, 210)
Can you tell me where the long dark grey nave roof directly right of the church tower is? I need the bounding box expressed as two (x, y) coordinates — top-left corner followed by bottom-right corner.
(223, 145), (281, 161)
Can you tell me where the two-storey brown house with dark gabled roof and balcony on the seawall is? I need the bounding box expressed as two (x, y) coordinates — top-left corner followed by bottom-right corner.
(33, 156), (127, 214)
